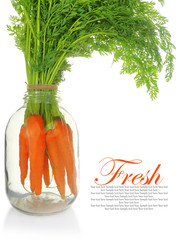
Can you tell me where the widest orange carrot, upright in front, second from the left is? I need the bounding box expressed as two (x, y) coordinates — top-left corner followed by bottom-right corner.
(27, 115), (45, 195)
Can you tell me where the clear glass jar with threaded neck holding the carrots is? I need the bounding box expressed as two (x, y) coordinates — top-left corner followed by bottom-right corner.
(5, 90), (79, 215)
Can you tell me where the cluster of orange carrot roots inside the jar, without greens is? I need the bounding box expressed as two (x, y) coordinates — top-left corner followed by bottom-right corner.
(19, 115), (77, 199)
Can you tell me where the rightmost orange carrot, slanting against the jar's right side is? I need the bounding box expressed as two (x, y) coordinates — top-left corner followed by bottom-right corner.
(54, 120), (77, 195)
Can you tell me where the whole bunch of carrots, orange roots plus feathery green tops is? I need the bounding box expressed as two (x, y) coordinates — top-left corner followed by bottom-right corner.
(8, 0), (175, 198)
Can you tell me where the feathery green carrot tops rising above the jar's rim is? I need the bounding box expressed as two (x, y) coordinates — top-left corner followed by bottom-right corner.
(8, 0), (174, 99)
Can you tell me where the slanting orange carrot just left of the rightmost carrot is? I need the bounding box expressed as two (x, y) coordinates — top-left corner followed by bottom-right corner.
(46, 129), (65, 199)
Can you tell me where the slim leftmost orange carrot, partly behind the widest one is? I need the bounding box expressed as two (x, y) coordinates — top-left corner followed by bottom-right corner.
(19, 125), (29, 186)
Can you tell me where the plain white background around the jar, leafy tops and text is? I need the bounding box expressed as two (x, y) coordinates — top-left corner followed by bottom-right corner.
(0, 0), (181, 240)
